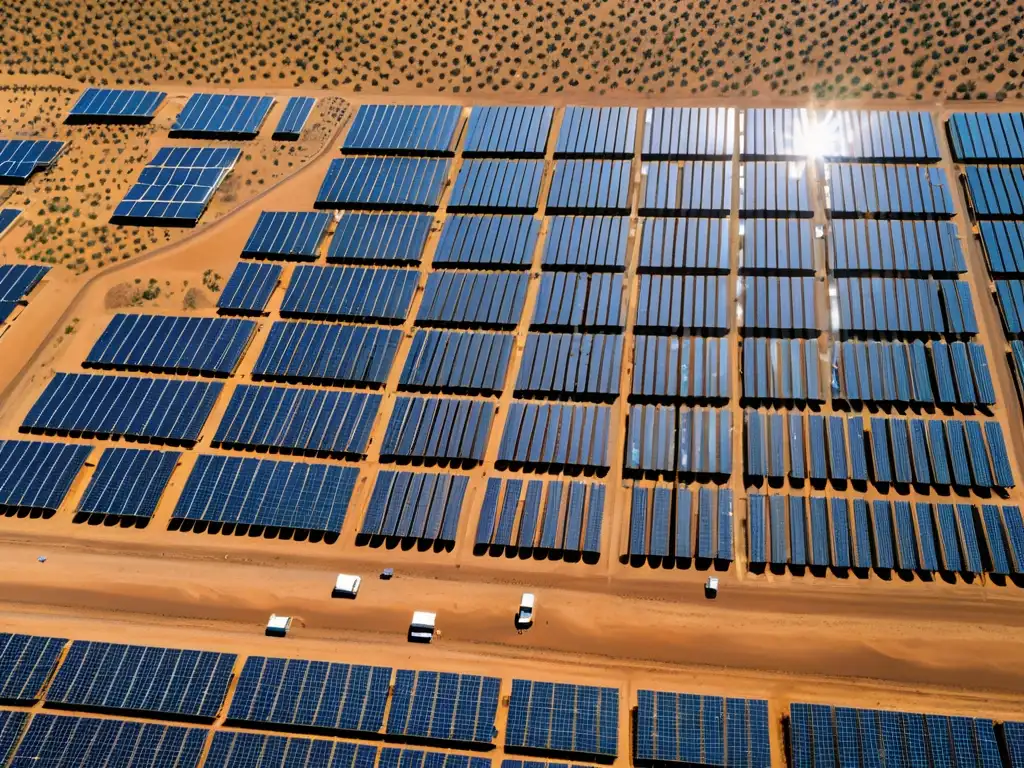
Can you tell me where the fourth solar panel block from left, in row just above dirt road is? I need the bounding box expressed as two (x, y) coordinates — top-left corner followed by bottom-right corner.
(356, 470), (469, 549)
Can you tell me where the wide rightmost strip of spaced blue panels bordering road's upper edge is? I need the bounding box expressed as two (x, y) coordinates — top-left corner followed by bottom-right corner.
(746, 494), (1024, 575)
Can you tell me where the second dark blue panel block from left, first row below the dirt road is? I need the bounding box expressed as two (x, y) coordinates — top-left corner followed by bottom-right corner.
(46, 640), (238, 721)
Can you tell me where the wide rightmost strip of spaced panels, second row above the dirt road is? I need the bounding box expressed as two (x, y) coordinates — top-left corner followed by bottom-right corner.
(744, 411), (1014, 489)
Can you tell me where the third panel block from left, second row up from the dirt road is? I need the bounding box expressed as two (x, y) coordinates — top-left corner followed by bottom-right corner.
(381, 397), (495, 466)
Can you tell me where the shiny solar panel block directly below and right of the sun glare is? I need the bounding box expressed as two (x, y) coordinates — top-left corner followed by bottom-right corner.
(824, 163), (953, 219)
